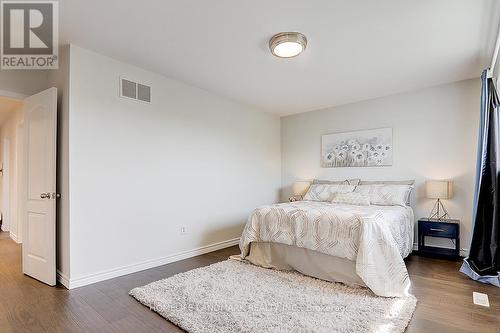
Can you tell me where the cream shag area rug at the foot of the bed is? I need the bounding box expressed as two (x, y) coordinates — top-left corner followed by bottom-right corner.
(130, 260), (417, 333)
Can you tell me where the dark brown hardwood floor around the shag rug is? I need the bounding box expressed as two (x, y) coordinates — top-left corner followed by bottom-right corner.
(0, 234), (500, 333)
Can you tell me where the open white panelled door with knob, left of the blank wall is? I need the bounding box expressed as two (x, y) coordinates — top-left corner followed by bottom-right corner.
(21, 88), (57, 286)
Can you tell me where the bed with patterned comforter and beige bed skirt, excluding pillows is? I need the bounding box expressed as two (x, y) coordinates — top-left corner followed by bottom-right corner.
(240, 183), (414, 297)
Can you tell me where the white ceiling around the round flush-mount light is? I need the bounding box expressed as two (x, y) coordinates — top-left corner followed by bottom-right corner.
(59, 0), (500, 115)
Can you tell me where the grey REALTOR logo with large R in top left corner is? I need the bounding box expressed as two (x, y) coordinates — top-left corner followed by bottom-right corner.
(0, 1), (59, 69)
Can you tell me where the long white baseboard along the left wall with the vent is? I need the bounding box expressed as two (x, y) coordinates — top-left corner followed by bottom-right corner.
(57, 237), (240, 289)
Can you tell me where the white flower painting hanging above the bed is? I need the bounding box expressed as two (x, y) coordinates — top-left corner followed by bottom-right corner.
(321, 128), (392, 168)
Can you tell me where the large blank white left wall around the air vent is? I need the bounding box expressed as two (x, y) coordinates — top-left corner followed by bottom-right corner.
(65, 46), (280, 285)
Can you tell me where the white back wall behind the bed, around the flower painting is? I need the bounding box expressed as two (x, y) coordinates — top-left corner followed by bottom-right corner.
(281, 80), (480, 249)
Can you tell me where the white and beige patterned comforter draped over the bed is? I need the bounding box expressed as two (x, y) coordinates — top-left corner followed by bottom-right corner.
(240, 201), (414, 297)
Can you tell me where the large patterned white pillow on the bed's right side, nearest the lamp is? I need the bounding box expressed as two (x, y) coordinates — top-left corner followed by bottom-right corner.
(354, 184), (413, 206)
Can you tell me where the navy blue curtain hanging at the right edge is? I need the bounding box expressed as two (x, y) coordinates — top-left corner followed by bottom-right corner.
(460, 70), (500, 287)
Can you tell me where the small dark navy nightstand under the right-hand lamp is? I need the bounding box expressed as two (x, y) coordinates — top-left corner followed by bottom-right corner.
(418, 218), (460, 260)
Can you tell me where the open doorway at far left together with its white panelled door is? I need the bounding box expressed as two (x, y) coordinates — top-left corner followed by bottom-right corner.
(0, 88), (58, 286)
